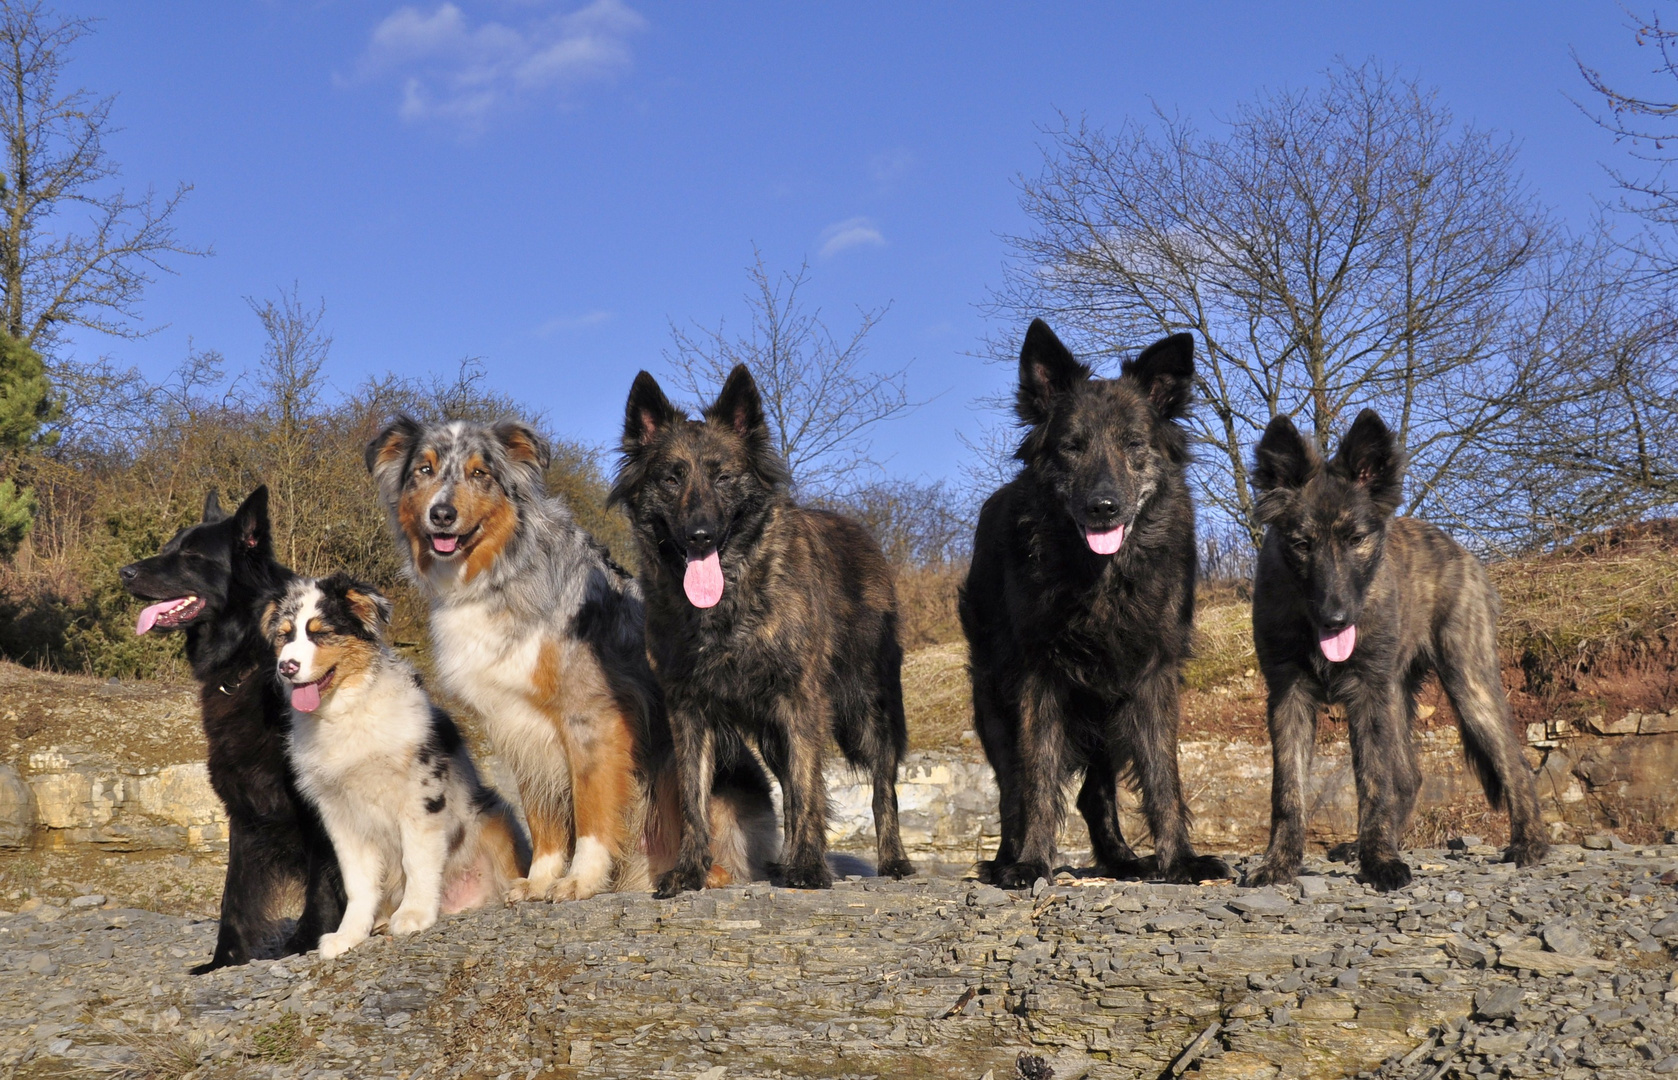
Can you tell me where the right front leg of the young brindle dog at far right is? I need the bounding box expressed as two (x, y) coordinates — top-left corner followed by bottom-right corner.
(1346, 681), (1415, 892)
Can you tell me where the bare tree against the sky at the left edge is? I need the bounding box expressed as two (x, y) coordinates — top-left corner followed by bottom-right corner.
(0, 0), (206, 359)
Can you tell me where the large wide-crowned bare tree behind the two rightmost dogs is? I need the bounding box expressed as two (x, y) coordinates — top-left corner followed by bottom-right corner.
(995, 64), (1550, 543)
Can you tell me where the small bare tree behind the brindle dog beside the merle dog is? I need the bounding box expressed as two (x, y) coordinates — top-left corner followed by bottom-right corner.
(664, 250), (916, 495)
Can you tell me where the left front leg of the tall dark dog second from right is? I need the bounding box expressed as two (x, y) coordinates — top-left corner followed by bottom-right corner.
(997, 676), (1067, 889)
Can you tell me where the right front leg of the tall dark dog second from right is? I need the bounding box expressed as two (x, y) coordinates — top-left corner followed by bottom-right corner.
(1113, 667), (1230, 884)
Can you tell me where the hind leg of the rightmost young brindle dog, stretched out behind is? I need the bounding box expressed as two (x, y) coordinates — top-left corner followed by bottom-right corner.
(1438, 585), (1550, 865)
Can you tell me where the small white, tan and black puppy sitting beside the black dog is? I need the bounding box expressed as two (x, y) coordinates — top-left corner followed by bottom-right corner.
(263, 574), (530, 958)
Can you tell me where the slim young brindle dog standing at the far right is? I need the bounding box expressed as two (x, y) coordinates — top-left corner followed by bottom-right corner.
(1248, 409), (1549, 890)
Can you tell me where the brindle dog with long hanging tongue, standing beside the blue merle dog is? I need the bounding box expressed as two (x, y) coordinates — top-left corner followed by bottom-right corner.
(611, 366), (913, 896)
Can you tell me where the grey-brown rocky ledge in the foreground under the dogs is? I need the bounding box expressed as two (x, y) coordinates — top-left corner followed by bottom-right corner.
(0, 839), (1678, 1080)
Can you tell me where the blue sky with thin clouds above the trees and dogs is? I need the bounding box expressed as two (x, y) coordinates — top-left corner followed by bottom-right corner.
(64, 0), (1660, 493)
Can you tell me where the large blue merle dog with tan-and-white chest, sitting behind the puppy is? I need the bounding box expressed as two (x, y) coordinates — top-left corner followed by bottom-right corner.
(367, 416), (775, 899)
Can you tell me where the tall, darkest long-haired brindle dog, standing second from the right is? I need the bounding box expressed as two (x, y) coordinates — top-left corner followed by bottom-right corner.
(960, 320), (1230, 887)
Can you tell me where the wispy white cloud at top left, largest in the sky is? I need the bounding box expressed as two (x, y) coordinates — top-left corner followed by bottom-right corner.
(357, 0), (646, 127)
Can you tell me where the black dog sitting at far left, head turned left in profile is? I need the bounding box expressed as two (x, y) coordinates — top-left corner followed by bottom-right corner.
(121, 488), (344, 974)
